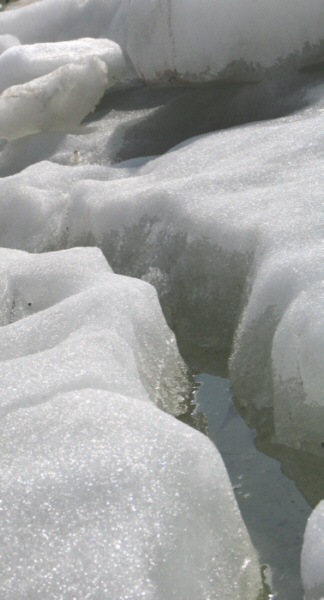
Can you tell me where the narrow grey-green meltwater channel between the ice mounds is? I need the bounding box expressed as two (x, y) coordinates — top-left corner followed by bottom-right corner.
(195, 374), (311, 600)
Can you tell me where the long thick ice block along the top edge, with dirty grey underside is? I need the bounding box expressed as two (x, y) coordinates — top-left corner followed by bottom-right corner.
(0, 0), (323, 85)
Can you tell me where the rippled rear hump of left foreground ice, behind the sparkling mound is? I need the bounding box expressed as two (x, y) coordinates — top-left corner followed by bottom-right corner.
(0, 249), (189, 414)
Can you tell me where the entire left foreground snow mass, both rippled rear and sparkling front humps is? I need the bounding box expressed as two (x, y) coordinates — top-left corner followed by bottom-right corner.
(0, 248), (261, 600)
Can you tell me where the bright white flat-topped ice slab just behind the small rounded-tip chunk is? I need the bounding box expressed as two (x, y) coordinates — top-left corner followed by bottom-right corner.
(0, 36), (126, 92)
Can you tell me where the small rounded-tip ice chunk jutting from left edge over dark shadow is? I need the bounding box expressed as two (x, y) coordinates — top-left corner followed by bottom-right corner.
(0, 57), (107, 140)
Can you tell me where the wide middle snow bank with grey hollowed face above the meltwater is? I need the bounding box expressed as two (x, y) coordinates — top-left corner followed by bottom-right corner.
(0, 81), (323, 455)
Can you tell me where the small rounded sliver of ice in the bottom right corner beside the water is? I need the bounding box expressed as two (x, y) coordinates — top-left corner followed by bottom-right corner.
(301, 501), (324, 600)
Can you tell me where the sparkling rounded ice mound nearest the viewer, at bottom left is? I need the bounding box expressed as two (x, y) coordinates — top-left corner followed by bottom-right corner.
(0, 389), (260, 600)
